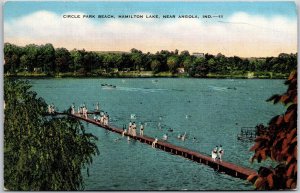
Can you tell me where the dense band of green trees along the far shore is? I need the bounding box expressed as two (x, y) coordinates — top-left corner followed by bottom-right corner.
(4, 43), (297, 77)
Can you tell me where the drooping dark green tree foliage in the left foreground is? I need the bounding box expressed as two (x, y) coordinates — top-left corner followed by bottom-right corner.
(4, 79), (99, 191)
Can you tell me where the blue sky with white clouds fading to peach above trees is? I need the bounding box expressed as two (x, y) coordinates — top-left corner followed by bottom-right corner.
(4, 1), (297, 57)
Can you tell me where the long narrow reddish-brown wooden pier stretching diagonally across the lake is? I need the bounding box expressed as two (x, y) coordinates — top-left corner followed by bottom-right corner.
(68, 114), (256, 179)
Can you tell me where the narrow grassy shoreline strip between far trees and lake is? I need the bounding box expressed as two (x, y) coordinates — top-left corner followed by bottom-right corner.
(4, 71), (289, 79)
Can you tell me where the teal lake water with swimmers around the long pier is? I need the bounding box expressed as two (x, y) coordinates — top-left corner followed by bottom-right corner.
(30, 78), (286, 190)
